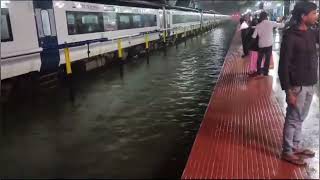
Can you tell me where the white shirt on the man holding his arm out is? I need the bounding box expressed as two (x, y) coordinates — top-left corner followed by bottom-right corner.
(252, 20), (284, 48)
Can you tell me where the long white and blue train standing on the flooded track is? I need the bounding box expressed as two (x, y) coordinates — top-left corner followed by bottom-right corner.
(1, 0), (230, 86)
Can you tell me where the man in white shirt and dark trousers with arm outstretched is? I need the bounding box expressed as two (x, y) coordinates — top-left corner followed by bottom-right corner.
(252, 11), (284, 76)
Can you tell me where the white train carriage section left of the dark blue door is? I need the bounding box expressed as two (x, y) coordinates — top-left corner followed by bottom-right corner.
(1, 1), (42, 80)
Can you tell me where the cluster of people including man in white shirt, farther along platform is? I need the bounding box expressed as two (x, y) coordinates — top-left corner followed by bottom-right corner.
(240, 11), (285, 77)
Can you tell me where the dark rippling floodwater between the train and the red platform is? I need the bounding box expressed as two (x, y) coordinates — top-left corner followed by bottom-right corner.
(0, 21), (235, 178)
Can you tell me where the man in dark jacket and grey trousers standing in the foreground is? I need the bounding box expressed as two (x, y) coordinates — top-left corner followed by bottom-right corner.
(278, 2), (319, 165)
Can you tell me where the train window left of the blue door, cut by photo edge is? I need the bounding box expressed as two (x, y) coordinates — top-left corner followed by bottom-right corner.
(1, 8), (13, 42)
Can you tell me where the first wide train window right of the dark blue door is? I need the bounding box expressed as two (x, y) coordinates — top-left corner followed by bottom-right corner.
(66, 11), (104, 35)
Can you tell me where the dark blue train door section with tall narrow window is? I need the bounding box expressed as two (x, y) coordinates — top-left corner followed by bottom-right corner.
(33, 1), (60, 73)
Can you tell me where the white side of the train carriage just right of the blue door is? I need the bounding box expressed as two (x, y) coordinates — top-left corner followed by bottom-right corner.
(54, 1), (160, 64)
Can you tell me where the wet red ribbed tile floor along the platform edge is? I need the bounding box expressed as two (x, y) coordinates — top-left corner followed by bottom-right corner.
(182, 29), (308, 179)
